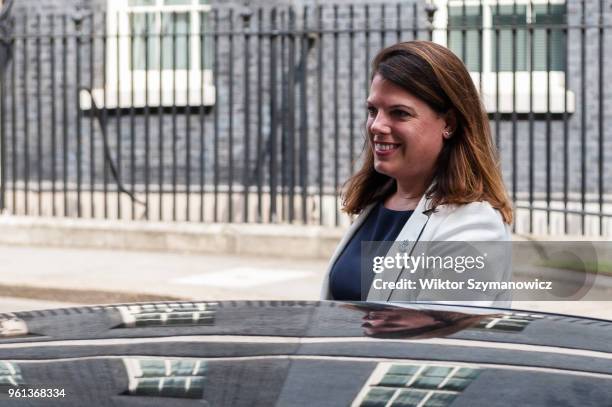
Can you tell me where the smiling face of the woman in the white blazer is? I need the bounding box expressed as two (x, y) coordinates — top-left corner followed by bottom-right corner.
(366, 74), (447, 183)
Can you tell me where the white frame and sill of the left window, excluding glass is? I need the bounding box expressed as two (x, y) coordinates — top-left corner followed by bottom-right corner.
(80, 0), (216, 110)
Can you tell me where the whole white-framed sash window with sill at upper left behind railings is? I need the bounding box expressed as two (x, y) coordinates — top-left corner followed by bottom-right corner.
(81, 0), (215, 109)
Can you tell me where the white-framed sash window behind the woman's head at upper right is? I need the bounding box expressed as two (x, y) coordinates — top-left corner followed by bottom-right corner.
(433, 0), (574, 113)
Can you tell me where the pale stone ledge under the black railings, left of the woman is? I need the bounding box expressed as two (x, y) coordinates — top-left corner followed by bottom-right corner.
(0, 215), (343, 259)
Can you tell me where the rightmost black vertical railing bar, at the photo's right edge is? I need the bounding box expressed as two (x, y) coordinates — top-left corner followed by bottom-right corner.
(597, 0), (606, 236)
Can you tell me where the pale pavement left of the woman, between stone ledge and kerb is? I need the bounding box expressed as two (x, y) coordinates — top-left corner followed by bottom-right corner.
(0, 246), (327, 300)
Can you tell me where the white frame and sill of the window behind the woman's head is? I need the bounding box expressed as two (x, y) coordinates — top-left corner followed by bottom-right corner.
(432, 0), (576, 113)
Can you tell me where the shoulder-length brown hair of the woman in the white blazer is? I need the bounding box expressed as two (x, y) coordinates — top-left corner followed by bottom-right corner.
(343, 41), (512, 224)
